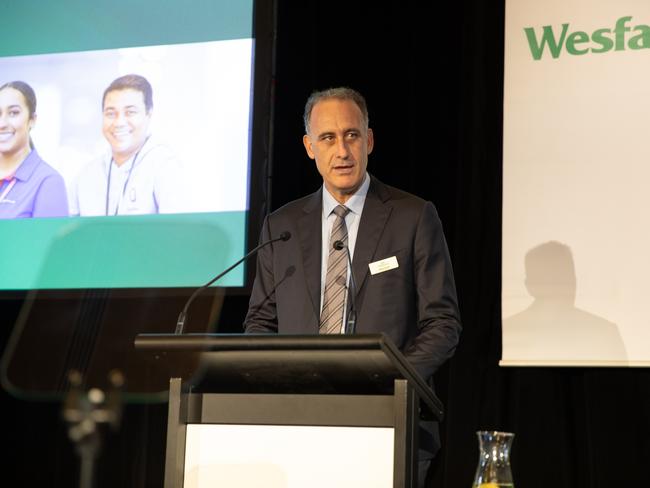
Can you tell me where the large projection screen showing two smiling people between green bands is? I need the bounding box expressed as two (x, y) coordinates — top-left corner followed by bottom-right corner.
(0, 0), (255, 290)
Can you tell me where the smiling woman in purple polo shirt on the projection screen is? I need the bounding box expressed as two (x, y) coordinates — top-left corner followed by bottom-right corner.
(0, 81), (68, 219)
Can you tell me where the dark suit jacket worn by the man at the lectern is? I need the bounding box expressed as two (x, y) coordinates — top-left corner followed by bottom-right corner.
(244, 177), (461, 454)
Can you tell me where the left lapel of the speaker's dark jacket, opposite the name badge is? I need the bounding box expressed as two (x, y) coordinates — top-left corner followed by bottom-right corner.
(298, 189), (323, 321)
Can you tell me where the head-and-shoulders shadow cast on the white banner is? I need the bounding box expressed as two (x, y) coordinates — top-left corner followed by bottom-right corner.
(502, 241), (627, 365)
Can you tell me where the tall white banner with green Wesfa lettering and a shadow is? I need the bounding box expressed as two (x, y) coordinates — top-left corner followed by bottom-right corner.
(500, 0), (650, 366)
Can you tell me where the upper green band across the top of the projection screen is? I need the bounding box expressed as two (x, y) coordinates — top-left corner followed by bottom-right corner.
(0, 0), (253, 56)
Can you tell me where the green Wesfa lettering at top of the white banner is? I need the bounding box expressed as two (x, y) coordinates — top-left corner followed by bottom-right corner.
(524, 16), (650, 61)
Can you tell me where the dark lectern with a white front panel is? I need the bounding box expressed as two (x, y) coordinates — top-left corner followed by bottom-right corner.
(135, 334), (442, 488)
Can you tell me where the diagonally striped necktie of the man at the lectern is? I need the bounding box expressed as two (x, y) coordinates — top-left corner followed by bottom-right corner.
(320, 205), (350, 334)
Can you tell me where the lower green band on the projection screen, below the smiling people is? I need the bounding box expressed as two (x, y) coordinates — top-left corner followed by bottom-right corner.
(0, 212), (246, 290)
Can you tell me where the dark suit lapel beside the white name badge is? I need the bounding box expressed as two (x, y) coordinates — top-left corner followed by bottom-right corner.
(352, 177), (393, 295)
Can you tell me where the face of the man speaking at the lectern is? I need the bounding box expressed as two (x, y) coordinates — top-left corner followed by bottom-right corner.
(303, 98), (374, 203)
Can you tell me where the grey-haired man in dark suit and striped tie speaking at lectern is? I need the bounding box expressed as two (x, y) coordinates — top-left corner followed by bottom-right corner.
(244, 88), (461, 484)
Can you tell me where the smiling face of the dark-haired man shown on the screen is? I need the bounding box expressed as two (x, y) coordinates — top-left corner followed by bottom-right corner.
(102, 88), (151, 164)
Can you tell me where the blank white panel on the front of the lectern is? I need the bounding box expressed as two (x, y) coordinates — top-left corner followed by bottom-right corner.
(184, 424), (395, 488)
